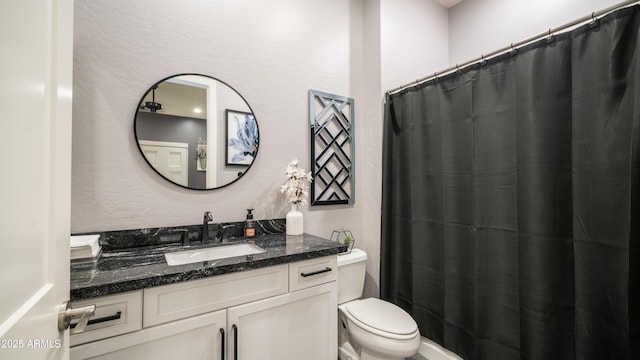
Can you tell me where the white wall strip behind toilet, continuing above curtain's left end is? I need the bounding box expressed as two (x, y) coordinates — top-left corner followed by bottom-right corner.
(356, 0), (448, 296)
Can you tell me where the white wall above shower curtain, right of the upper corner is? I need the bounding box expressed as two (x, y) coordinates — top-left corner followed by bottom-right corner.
(449, 0), (621, 66)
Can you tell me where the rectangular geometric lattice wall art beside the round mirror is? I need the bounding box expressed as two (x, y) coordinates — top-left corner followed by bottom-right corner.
(309, 90), (356, 205)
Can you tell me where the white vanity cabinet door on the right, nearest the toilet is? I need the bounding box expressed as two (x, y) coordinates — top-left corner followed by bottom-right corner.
(227, 281), (338, 360)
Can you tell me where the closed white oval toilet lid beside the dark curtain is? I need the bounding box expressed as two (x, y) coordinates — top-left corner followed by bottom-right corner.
(345, 298), (418, 335)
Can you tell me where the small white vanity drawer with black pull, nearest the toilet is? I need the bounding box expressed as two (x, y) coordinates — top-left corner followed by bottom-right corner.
(289, 255), (338, 291)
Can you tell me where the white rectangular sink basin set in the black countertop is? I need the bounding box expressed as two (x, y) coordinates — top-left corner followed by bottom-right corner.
(164, 244), (265, 266)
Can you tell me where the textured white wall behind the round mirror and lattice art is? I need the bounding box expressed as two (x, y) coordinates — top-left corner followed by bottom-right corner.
(71, 0), (366, 246)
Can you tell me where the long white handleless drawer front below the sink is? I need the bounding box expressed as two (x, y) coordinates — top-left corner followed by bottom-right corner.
(143, 264), (289, 327)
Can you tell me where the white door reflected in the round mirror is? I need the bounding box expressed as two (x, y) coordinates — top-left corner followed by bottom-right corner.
(138, 140), (189, 187)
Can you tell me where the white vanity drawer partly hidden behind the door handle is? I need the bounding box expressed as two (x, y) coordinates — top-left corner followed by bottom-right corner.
(69, 290), (142, 346)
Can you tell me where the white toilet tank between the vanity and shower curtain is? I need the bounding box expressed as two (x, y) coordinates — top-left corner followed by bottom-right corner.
(338, 249), (367, 304)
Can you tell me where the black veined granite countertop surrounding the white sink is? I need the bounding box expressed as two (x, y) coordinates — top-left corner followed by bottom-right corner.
(70, 233), (346, 301)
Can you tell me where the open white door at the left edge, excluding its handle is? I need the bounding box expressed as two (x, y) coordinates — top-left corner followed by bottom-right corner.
(0, 0), (73, 359)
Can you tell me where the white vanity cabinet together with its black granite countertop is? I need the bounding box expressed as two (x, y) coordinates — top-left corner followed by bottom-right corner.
(70, 233), (345, 360)
